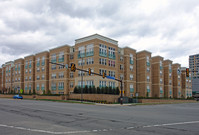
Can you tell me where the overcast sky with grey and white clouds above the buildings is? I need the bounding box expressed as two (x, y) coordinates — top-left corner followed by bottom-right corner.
(0, 0), (199, 67)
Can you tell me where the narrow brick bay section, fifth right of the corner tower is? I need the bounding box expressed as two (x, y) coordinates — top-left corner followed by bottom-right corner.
(172, 63), (182, 98)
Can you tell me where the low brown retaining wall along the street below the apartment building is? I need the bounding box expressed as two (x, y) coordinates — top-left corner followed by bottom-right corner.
(0, 94), (197, 105)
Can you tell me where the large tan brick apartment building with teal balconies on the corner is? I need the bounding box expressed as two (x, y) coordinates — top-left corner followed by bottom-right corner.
(0, 34), (191, 98)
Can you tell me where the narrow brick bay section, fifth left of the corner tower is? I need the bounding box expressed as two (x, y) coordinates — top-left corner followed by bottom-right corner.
(5, 61), (14, 93)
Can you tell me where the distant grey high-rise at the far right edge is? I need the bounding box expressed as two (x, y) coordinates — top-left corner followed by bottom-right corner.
(189, 54), (199, 94)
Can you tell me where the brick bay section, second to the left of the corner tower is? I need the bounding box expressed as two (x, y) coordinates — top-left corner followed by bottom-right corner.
(35, 51), (49, 94)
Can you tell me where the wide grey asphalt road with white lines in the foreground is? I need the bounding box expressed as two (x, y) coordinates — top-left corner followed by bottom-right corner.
(0, 98), (199, 135)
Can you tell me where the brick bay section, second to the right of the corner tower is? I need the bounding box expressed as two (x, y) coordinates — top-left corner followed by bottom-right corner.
(136, 51), (152, 97)
